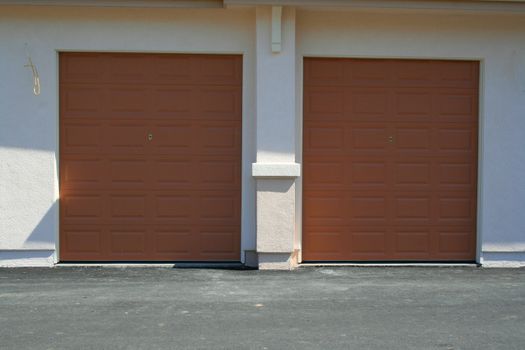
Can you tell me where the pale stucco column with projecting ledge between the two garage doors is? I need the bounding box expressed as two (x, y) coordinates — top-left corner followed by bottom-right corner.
(252, 6), (300, 269)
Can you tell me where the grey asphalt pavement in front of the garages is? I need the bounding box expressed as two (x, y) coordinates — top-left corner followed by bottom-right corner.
(0, 267), (525, 350)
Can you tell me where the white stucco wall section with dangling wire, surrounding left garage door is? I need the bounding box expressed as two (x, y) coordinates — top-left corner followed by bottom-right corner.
(0, 6), (255, 265)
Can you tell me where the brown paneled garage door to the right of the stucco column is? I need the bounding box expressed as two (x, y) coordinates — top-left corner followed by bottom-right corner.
(303, 58), (479, 261)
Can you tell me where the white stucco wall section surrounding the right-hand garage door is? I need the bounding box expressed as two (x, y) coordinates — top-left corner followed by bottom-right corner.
(296, 10), (525, 263)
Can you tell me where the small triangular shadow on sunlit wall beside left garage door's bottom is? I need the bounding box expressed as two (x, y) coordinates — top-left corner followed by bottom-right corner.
(24, 200), (59, 250)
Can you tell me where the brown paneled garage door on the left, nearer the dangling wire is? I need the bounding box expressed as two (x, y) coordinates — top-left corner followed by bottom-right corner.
(60, 53), (242, 261)
